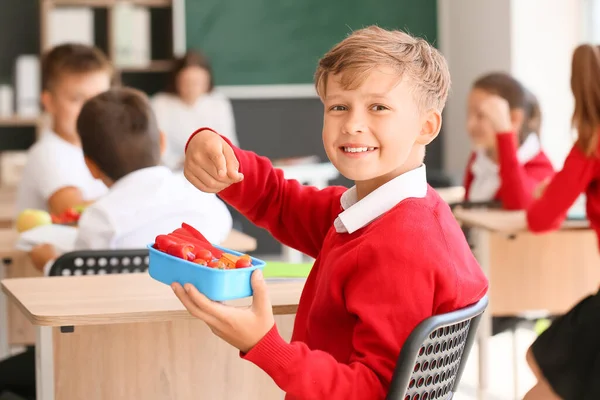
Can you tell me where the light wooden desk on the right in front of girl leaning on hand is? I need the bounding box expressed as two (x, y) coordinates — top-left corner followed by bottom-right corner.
(454, 208), (600, 399)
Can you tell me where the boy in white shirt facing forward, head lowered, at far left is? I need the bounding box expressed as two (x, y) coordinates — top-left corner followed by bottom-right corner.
(16, 44), (112, 214)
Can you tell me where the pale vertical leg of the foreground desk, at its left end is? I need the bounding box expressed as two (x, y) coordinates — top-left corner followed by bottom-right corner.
(35, 326), (54, 400)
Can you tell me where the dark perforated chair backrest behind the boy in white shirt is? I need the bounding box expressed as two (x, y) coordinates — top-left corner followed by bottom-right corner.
(50, 249), (149, 276)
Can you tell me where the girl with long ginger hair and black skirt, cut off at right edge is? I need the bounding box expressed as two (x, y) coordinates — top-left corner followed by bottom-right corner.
(525, 45), (600, 400)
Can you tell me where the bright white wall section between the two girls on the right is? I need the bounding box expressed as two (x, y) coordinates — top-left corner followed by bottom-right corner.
(511, 0), (585, 168)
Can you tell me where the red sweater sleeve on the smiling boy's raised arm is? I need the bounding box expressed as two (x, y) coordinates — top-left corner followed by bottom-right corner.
(218, 138), (346, 258)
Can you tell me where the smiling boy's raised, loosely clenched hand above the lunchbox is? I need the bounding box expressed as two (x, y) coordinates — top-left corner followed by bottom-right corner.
(183, 130), (244, 193)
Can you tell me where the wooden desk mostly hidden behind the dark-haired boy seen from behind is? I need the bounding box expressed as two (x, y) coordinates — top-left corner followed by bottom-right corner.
(0, 229), (256, 359)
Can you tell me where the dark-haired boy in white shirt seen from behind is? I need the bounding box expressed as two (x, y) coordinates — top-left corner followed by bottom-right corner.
(32, 88), (232, 269)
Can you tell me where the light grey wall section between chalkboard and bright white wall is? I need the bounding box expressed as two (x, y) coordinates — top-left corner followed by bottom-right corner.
(438, 0), (511, 183)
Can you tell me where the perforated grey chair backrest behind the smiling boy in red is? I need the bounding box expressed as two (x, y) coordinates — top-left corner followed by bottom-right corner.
(386, 295), (488, 400)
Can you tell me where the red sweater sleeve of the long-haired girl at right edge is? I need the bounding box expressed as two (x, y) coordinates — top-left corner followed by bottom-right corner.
(527, 145), (596, 232)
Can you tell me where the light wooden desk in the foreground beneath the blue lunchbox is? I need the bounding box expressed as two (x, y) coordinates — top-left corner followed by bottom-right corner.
(2, 273), (304, 400)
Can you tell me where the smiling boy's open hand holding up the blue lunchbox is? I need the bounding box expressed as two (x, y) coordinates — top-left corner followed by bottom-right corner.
(171, 270), (275, 353)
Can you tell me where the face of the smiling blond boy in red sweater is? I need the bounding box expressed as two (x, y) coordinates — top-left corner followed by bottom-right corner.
(323, 67), (441, 202)
